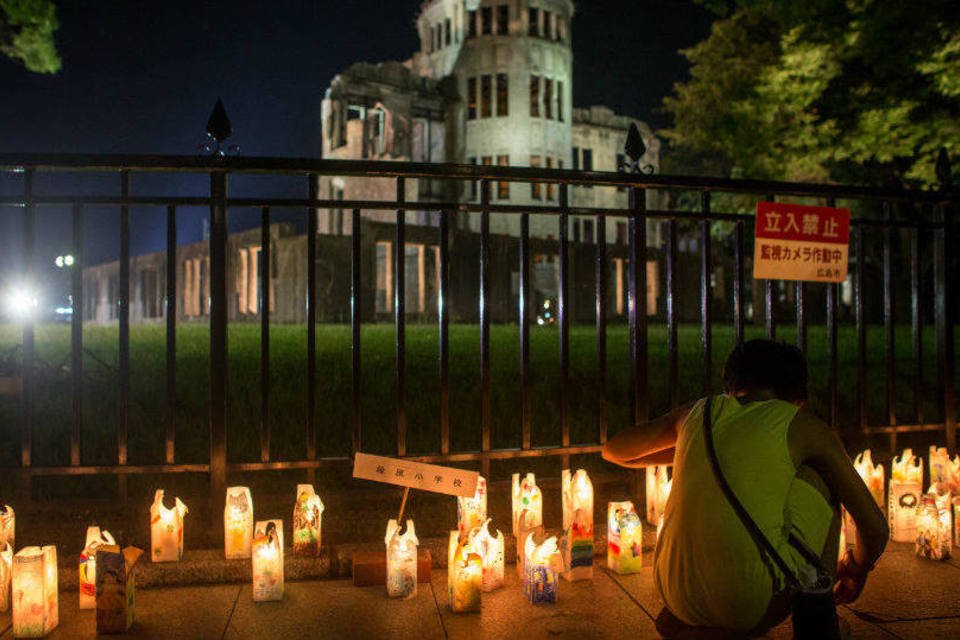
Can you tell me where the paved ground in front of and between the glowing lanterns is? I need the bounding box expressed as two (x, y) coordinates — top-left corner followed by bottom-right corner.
(0, 545), (960, 640)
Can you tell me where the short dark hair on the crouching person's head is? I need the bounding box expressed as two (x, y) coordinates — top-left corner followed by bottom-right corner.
(723, 340), (807, 402)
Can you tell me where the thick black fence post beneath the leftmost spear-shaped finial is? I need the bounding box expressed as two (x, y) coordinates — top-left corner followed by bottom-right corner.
(210, 171), (227, 543)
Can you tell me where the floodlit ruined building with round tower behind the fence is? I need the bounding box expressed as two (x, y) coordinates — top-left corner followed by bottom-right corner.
(83, 0), (661, 322)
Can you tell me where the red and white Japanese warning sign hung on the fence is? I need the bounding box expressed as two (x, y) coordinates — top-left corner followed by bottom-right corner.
(753, 202), (850, 282)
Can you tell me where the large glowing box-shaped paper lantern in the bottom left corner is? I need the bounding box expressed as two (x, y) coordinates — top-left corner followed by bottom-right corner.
(13, 546), (60, 638)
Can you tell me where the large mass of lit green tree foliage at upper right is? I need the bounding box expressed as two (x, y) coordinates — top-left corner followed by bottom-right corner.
(661, 0), (960, 187)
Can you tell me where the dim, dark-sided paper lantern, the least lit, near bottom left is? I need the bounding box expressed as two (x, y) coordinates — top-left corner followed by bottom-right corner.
(97, 545), (143, 634)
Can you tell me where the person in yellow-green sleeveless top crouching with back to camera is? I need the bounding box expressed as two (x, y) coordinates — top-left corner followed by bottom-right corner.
(603, 340), (889, 638)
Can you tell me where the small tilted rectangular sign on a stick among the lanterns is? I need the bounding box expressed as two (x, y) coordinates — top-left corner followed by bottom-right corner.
(353, 453), (480, 498)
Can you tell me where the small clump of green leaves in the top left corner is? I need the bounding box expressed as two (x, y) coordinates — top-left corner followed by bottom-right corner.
(0, 0), (61, 73)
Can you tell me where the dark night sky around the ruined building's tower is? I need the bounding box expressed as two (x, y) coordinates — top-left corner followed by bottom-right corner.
(0, 0), (711, 298)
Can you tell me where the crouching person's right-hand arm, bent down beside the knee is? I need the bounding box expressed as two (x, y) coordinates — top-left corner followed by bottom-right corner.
(789, 410), (890, 602)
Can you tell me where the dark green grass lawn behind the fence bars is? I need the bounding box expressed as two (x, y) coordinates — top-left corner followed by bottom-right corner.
(0, 324), (956, 466)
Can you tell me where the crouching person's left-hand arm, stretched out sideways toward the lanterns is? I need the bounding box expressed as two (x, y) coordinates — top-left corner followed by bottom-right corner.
(603, 404), (693, 469)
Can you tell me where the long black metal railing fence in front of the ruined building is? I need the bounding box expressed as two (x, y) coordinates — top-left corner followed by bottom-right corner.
(0, 154), (957, 496)
